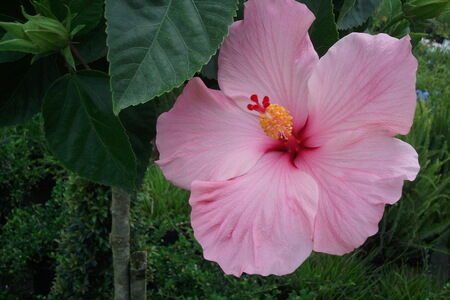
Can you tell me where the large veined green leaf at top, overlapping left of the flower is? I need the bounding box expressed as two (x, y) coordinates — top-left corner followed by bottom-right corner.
(105, 0), (237, 114)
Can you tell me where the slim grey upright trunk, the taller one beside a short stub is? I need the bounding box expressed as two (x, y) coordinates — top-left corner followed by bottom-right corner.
(110, 187), (131, 300)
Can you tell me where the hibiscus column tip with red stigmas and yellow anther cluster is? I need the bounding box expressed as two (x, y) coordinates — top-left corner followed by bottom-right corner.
(247, 95), (292, 141)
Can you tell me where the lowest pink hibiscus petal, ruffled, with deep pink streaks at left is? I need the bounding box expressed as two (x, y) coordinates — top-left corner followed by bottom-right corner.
(189, 152), (318, 276)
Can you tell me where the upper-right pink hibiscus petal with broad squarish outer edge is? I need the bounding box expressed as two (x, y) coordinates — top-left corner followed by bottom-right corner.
(306, 33), (417, 146)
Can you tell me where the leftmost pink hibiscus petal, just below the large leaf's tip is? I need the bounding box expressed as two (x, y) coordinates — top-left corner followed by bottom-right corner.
(156, 78), (276, 189)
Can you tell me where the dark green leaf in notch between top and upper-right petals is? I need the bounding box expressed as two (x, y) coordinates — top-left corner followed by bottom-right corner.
(299, 0), (339, 56)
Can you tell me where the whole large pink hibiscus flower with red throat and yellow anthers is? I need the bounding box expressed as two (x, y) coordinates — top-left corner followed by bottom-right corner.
(156, 0), (419, 276)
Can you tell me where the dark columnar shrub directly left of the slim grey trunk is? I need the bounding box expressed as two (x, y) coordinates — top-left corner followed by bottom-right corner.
(49, 176), (112, 300)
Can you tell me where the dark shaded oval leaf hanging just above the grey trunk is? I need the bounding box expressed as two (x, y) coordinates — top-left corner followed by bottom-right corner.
(43, 71), (136, 189)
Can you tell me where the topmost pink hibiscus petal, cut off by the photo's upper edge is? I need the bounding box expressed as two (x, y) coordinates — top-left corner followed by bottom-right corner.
(218, 0), (318, 124)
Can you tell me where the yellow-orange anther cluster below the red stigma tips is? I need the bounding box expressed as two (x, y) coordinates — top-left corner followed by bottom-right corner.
(259, 104), (292, 140)
